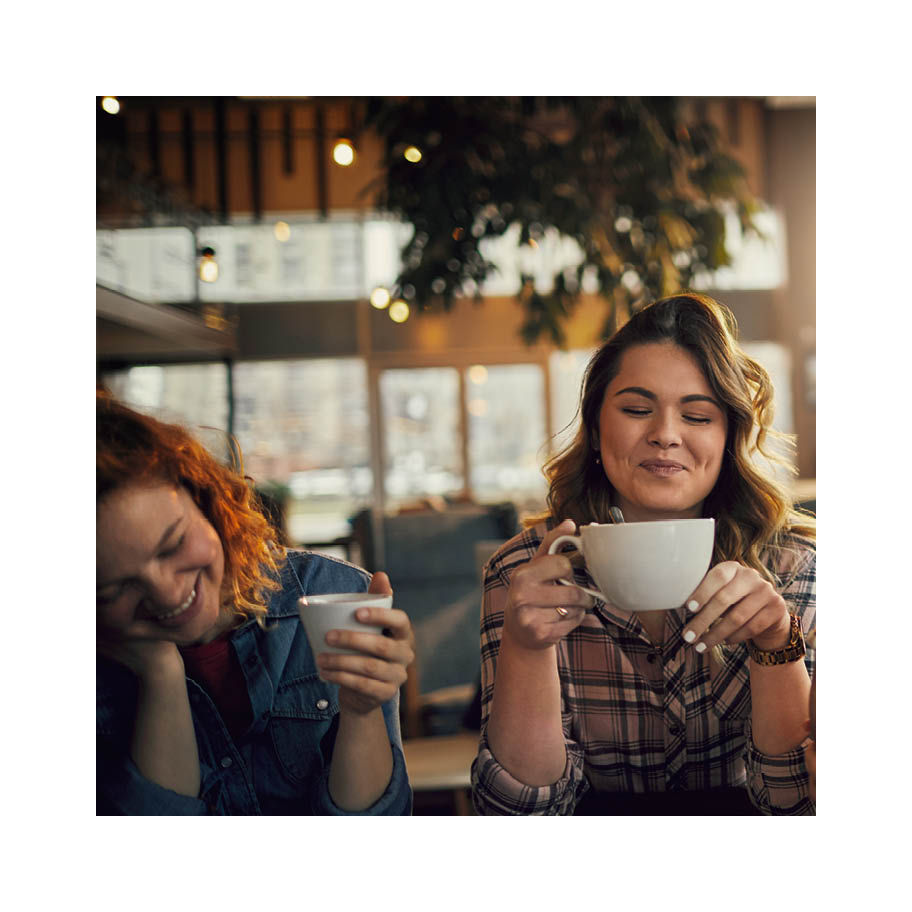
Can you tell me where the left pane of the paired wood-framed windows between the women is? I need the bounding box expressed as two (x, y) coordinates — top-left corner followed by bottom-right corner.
(380, 367), (465, 507)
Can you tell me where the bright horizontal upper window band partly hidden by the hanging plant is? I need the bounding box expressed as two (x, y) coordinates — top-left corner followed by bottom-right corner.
(95, 209), (787, 303)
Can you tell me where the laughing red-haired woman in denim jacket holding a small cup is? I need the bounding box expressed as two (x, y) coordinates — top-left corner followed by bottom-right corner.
(96, 392), (414, 815)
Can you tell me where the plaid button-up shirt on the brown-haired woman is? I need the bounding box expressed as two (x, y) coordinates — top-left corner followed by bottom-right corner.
(472, 526), (816, 814)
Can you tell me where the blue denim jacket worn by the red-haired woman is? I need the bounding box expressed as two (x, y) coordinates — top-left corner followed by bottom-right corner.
(96, 551), (412, 815)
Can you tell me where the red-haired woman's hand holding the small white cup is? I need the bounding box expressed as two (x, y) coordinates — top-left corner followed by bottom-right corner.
(317, 572), (415, 715)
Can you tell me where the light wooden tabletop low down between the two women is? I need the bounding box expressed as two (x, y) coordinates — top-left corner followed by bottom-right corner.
(402, 731), (478, 814)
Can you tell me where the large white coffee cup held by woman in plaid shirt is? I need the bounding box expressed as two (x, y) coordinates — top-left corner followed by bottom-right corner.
(548, 519), (715, 611)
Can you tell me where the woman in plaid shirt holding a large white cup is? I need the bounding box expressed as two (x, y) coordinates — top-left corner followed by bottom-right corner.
(472, 293), (816, 814)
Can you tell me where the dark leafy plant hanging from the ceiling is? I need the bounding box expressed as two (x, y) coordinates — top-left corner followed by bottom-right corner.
(365, 96), (757, 345)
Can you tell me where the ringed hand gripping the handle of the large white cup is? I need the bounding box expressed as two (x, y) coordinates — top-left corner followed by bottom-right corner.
(503, 519), (595, 650)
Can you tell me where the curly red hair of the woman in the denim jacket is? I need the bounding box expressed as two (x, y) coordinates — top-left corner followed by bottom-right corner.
(95, 389), (285, 623)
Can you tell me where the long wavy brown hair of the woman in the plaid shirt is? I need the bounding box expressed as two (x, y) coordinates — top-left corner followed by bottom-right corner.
(533, 292), (816, 580)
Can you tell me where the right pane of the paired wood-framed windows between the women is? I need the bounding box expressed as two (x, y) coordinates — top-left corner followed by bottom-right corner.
(465, 364), (547, 509)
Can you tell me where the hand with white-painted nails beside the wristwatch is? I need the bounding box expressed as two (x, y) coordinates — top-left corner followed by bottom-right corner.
(684, 561), (790, 652)
